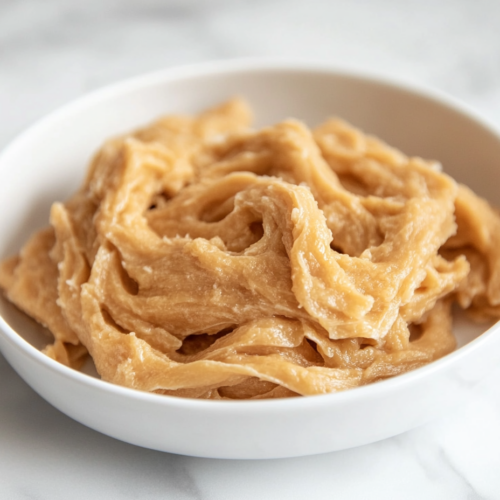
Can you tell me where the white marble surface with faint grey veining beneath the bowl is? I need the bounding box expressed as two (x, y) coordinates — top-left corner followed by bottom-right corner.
(0, 0), (500, 500)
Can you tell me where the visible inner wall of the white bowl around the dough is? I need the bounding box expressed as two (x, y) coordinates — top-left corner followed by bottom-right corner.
(0, 62), (500, 368)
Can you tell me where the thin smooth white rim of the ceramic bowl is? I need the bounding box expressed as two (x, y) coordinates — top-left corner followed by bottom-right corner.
(0, 58), (500, 412)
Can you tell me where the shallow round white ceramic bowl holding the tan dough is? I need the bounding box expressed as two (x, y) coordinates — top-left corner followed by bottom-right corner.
(0, 62), (500, 458)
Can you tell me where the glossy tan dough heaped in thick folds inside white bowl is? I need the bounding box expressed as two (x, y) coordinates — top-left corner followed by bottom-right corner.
(0, 100), (500, 399)
